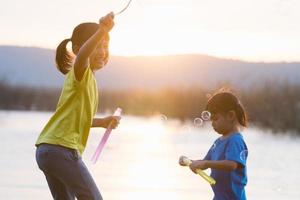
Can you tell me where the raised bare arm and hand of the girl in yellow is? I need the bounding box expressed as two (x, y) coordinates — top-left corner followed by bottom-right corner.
(74, 12), (114, 81)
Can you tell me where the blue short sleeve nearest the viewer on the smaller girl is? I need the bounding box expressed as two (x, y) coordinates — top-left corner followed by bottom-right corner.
(225, 137), (248, 167)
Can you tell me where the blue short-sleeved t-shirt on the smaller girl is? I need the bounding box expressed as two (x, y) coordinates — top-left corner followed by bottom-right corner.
(204, 133), (248, 200)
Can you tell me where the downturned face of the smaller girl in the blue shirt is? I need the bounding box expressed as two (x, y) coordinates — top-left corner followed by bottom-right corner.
(211, 113), (232, 135)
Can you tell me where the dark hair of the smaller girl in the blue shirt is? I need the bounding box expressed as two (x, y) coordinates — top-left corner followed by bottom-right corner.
(206, 92), (248, 127)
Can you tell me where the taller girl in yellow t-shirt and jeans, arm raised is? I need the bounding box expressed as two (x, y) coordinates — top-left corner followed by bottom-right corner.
(36, 13), (118, 200)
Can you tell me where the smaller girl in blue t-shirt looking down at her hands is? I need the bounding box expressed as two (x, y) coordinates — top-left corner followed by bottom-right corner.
(179, 92), (248, 200)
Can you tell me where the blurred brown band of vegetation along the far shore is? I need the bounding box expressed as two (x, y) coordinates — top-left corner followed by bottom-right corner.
(0, 81), (300, 135)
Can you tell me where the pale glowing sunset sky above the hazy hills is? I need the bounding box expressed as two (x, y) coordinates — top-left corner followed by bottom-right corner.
(0, 0), (300, 61)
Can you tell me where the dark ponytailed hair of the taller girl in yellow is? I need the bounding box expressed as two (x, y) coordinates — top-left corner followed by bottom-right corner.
(55, 23), (99, 74)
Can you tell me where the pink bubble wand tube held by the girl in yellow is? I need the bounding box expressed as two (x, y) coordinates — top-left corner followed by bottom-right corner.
(91, 108), (122, 164)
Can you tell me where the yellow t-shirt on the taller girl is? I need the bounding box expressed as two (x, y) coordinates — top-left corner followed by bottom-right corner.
(36, 67), (98, 154)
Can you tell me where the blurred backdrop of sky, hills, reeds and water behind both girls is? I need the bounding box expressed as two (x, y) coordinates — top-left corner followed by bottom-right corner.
(0, 0), (300, 200)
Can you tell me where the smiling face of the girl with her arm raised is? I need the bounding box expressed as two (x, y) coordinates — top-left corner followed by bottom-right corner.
(90, 40), (109, 70)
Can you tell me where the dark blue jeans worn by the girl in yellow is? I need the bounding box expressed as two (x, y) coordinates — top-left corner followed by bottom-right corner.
(36, 144), (102, 200)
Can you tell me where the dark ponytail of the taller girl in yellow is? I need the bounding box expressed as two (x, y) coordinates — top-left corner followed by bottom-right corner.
(55, 39), (73, 74)
